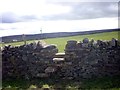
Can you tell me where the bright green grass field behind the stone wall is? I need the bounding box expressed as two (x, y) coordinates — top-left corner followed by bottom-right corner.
(0, 31), (120, 52)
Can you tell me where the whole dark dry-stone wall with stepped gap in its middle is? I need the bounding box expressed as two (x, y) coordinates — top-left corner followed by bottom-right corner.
(2, 38), (120, 79)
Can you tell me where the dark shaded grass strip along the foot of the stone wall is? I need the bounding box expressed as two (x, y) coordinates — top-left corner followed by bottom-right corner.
(3, 76), (120, 90)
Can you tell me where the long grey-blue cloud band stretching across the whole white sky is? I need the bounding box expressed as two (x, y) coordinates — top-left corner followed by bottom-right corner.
(0, 0), (118, 23)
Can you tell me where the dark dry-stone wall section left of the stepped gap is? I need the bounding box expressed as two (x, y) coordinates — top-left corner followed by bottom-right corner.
(2, 42), (58, 79)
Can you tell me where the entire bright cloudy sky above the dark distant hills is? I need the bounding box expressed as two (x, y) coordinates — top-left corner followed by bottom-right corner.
(0, 0), (119, 37)
